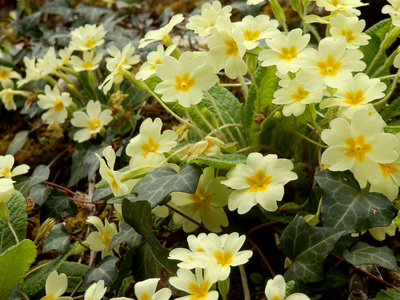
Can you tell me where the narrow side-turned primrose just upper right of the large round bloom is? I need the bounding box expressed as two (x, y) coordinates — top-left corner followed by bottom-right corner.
(206, 17), (247, 79)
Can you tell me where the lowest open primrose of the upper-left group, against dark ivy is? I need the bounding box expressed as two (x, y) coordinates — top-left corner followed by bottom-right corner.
(71, 100), (112, 143)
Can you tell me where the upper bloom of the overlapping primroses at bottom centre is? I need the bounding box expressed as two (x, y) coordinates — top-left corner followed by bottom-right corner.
(192, 232), (253, 280)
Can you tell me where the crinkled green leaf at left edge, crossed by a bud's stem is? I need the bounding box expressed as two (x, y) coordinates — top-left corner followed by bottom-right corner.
(0, 191), (28, 253)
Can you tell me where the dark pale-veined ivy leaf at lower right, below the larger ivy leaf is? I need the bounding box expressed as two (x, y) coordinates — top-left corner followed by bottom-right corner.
(280, 217), (343, 282)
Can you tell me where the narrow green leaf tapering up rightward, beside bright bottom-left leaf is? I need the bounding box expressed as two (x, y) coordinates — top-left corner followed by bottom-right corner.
(20, 242), (78, 298)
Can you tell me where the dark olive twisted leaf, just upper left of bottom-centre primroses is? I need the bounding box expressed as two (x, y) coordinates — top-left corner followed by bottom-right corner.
(122, 199), (177, 273)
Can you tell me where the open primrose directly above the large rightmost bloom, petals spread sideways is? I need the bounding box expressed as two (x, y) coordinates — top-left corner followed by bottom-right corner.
(320, 73), (386, 119)
